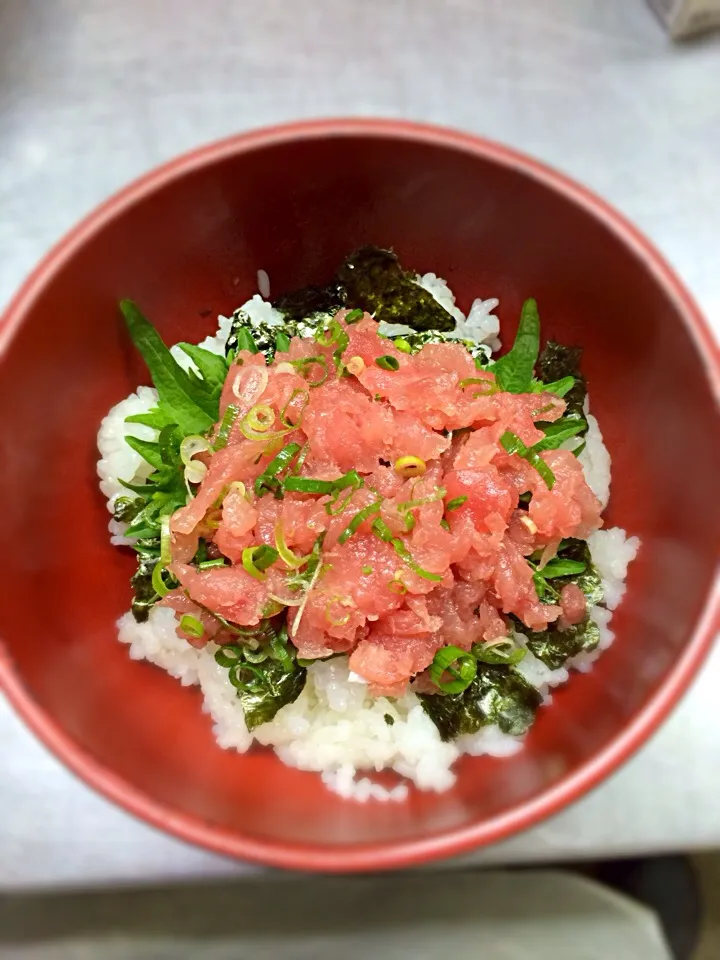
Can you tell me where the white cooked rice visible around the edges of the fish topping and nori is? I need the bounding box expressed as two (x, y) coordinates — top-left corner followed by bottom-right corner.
(98, 284), (639, 802)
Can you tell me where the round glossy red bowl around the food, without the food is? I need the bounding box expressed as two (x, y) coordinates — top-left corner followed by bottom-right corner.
(0, 120), (720, 870)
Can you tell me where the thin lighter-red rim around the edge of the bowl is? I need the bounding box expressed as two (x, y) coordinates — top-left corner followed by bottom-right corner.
(0, 118), (720, 872)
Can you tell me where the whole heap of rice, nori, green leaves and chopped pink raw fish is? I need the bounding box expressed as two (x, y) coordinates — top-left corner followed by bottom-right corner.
(98, 249), (639, 802)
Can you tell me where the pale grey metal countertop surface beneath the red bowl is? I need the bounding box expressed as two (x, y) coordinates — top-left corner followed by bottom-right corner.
(0, 0), (720, 888)
